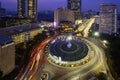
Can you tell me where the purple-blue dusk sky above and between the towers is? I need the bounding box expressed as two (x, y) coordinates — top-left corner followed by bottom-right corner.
(0, 0), (120, 11)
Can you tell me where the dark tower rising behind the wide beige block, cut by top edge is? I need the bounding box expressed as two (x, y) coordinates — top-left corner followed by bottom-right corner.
(67, 0), (81, 20)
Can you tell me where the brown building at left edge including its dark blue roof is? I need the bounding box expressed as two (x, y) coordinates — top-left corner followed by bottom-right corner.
(0, 35), (15, 76)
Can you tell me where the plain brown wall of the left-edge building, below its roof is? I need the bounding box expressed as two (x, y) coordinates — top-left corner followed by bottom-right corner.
(0, 42), (15, 75)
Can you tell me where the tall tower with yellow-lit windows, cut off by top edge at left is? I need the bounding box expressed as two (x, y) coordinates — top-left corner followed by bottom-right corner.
(18, 0), (37, 18)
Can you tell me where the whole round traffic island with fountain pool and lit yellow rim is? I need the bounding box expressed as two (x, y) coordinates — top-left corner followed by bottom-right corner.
(45, 35), (94, 67)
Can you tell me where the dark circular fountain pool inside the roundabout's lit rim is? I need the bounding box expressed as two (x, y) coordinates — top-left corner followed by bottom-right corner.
(49, 36), (88, 61)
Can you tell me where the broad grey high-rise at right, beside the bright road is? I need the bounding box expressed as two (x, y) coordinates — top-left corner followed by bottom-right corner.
(99, 4), (117, 34)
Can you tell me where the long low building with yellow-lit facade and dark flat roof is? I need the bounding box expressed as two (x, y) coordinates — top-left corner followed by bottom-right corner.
(0, 24), (43, 44)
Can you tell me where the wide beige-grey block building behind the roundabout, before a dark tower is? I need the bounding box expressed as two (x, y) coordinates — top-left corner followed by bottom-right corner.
(54, 8), (75, 26)
